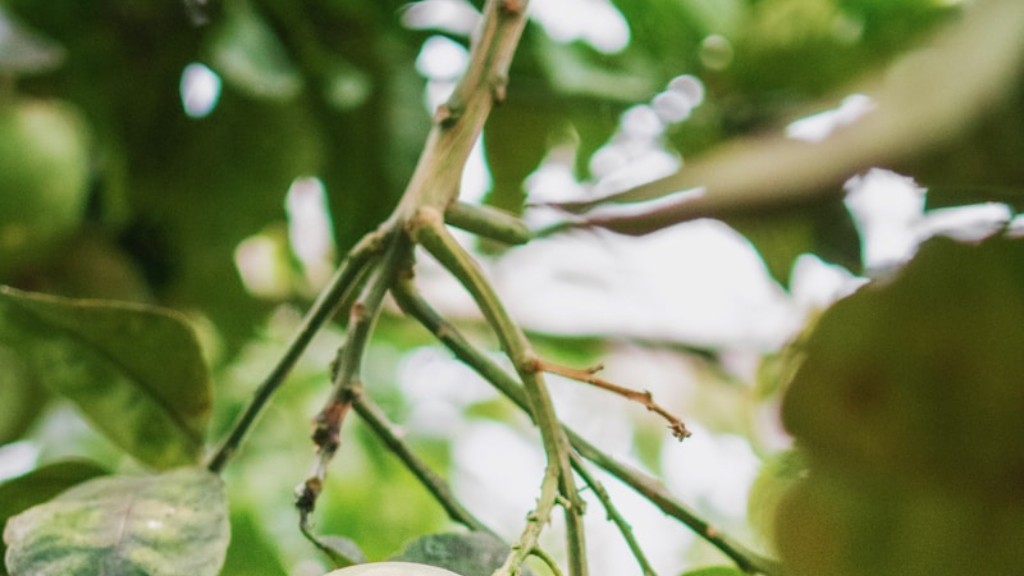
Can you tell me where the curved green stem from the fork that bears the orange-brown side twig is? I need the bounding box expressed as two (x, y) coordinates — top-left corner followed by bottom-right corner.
(410, 207), (587, 576)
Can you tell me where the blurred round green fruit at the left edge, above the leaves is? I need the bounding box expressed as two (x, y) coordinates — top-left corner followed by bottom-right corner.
(0, 100), (89, 280)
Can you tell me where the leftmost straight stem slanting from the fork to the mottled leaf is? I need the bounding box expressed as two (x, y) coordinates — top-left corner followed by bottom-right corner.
(207, 226), (382, 474)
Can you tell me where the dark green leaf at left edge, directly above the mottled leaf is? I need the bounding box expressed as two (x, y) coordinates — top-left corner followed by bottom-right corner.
(0, 287), (211, 469)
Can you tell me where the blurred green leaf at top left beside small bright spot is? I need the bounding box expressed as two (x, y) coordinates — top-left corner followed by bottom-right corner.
(208, 0), (303, 100)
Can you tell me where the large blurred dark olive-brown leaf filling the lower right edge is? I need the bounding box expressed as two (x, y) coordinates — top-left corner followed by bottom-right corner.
(774, 237), (1024, 576)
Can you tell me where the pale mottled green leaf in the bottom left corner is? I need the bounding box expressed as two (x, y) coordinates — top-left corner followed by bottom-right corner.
(3, 468), (229, 576)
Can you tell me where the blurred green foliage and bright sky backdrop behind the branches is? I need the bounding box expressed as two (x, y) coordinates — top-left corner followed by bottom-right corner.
(0, 0), (1024, 574)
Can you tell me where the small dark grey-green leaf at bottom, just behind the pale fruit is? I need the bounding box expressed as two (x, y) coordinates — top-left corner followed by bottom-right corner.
(390, 532), (530, 576)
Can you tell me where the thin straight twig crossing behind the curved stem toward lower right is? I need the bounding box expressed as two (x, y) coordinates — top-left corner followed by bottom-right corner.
(392, 282), (782, 576)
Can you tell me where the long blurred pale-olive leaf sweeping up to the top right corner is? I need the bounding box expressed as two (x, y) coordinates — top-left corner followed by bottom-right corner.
(565, 0), (1024, 234)
